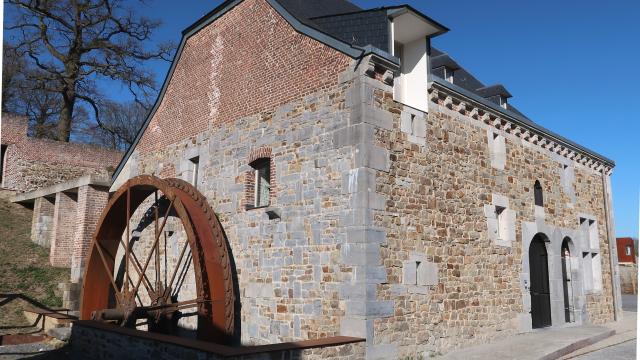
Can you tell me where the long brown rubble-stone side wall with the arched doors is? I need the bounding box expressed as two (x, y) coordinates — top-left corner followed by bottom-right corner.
(373, 83), (613, 355)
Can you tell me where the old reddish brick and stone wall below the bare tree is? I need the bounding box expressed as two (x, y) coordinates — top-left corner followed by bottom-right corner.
(0, 113), (122, 192)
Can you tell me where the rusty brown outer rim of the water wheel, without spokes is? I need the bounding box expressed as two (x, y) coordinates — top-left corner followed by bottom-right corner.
(80, 175), (235, 344)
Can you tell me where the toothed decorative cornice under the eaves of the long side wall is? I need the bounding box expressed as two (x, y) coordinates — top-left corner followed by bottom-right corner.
(429, 82), (613, 175)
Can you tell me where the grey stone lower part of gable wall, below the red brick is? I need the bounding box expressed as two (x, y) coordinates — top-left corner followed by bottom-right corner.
(132, 79), (355, 344)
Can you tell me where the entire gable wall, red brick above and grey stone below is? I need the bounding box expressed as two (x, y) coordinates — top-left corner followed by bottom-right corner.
(114, 0), (368, 344)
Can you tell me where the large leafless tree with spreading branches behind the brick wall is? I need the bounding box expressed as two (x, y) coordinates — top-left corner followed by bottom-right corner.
(6, 0), (174, 141)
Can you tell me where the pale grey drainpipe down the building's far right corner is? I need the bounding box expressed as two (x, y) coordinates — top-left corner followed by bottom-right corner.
(602, 173), (622, 321)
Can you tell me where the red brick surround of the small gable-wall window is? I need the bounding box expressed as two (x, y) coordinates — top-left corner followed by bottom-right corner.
(243, 146), (276, 210)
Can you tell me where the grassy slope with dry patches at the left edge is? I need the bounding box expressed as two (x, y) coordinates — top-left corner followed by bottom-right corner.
(0, 190), (69, 331)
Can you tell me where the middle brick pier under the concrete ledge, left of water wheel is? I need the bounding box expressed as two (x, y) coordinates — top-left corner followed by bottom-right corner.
(49, 192), (78, 267)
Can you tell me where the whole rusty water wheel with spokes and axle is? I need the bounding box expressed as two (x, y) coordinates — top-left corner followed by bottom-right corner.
(80, 175), (235, 344)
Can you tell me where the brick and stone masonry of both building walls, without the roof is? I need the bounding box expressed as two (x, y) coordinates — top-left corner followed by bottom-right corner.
(114, 0), (617, 358)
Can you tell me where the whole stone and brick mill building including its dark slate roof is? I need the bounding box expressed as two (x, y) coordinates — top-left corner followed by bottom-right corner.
(100, 0), (621, 358)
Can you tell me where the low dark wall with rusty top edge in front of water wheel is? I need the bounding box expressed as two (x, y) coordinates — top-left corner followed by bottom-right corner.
(71, 321), (365, 360)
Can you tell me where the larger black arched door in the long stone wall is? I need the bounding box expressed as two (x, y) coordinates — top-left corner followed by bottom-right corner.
(529, 233), (551, 329)
